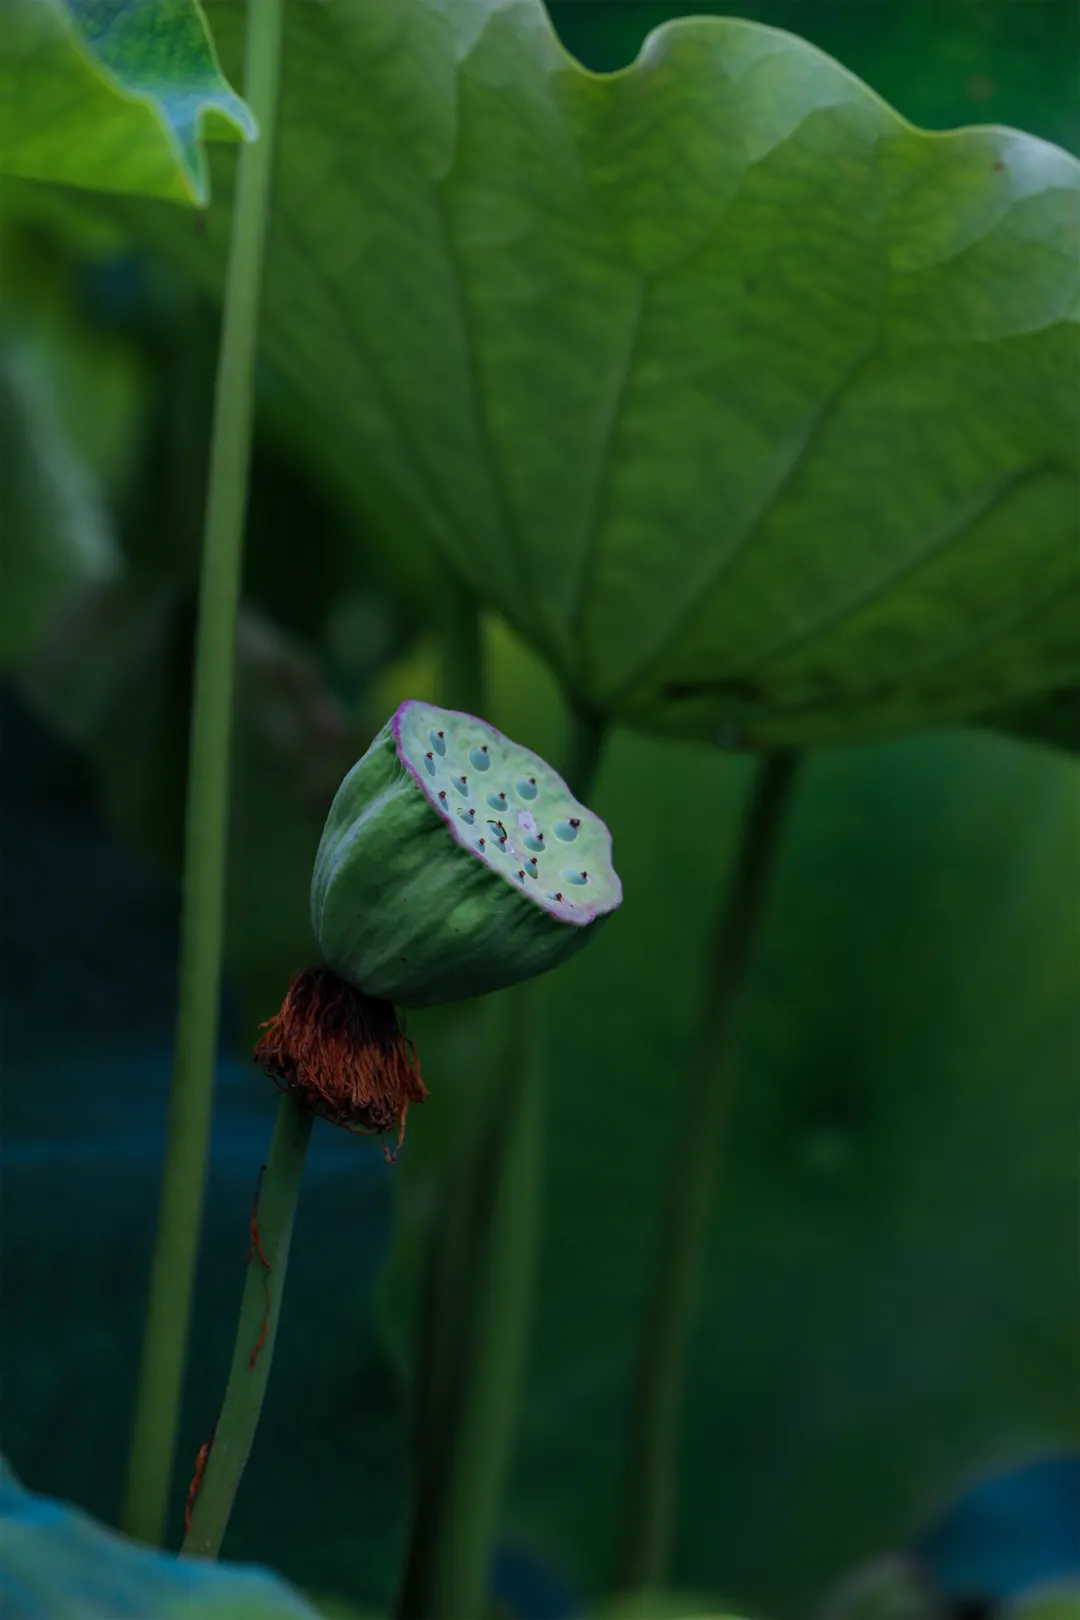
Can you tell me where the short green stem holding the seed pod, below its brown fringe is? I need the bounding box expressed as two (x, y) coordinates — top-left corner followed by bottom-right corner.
(183, 1092), (314, 1558)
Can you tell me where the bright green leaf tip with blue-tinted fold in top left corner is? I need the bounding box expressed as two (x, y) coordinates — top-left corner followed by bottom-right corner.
(0, 0), (256, 204)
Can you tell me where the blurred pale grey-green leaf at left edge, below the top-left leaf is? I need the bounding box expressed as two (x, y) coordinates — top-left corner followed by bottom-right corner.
(0, 343), (118, 667)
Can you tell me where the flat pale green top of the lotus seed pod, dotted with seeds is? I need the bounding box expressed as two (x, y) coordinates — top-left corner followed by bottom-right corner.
(390, 700), (622, 927)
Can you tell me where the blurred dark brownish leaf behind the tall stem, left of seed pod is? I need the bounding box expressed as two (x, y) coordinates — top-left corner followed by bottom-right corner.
(11, 582), (374, 1035)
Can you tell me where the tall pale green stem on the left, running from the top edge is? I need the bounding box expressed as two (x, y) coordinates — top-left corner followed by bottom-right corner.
(123, 0), (283, 1542)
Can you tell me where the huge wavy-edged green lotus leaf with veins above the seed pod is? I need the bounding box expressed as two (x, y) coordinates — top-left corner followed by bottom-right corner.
(111, 0), (1080, 745)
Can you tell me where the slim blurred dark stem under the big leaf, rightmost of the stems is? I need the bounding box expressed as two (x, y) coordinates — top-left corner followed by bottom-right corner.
(619, 753), (797, 1591)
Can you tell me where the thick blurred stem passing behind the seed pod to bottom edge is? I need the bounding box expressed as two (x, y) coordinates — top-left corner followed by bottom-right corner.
(397, 721), (604, 1620)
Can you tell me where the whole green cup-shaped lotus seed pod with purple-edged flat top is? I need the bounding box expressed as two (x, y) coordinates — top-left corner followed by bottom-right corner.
(311, 701), (622, 1008)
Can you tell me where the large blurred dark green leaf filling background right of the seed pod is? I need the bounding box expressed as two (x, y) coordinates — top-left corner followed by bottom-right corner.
(382, 622), (1080, 1617)
